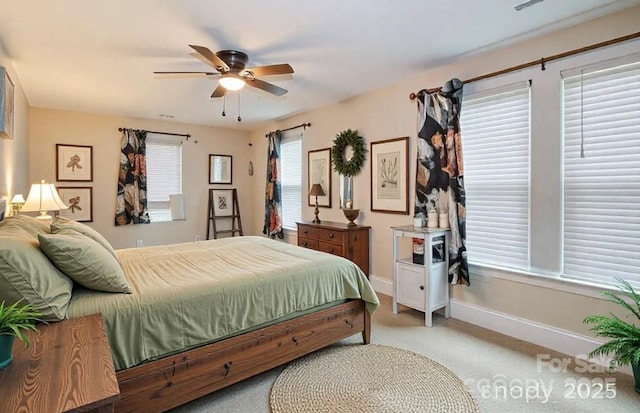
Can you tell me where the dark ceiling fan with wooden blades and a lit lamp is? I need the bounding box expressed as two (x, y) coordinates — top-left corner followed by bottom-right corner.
(153, 45), (293, 98)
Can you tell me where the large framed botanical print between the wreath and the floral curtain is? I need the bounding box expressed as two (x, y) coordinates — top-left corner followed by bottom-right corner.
(371, 137), (409, 215)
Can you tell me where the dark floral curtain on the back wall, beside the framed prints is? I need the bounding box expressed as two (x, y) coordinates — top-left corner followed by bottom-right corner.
(115, 129), (150, 226)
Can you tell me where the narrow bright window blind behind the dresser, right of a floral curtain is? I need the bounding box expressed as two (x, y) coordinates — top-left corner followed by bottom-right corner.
(280, 133), (302, 230)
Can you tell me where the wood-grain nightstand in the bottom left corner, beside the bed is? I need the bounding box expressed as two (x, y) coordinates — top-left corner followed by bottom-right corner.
(0, 314), (120, 413)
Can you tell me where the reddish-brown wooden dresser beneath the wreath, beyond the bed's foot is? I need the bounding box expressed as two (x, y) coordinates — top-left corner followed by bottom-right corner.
(297, 221), (371, 277)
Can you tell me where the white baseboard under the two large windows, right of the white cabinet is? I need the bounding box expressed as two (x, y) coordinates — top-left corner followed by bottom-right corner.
(450, 300), (633, 374)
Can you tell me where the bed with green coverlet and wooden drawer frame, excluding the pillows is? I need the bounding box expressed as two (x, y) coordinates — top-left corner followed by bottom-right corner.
(0, 216), (378, 412)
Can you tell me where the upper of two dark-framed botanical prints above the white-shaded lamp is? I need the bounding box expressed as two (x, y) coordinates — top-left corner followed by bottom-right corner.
(56, 144), (93, 182)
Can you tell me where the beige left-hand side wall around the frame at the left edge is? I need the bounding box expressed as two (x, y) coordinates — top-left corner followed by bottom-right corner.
(0, 42), (29, 202)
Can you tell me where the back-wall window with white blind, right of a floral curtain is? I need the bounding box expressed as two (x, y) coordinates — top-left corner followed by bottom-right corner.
(147, 133), (182, 222)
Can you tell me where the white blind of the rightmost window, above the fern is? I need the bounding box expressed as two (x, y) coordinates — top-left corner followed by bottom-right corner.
(562, 56), (640, 285)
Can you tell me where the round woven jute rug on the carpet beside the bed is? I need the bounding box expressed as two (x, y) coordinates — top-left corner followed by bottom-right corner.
(270, 344), (480, 413)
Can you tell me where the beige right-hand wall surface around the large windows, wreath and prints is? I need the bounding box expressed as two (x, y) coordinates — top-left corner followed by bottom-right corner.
(251, 8), (640, 334)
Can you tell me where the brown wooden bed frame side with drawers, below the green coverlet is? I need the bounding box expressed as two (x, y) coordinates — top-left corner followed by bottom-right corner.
(115, 300), (371, 413)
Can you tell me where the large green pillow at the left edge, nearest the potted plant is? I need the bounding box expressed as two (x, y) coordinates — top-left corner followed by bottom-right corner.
(0, 227), (73, 321)
